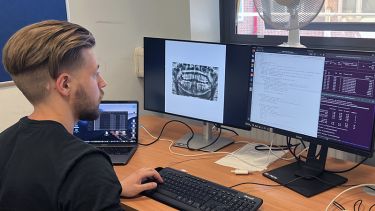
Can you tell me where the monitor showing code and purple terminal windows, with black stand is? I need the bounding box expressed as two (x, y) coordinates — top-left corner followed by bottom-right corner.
(247, 46), (375, 197)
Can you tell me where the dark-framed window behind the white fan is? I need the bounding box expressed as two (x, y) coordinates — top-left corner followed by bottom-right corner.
(220, 0), (375, 50)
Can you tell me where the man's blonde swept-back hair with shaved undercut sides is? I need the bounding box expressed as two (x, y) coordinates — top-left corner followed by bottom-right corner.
(2, 20), (95, 104)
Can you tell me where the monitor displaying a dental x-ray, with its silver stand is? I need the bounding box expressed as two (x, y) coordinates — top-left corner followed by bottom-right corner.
(144, 37), (251, 151)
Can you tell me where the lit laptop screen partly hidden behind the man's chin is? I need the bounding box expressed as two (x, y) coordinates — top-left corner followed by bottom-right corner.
(73, 101), (138, 144)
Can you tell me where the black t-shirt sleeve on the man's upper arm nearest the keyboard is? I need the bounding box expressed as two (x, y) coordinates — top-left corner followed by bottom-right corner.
(58, 153), (123, 210)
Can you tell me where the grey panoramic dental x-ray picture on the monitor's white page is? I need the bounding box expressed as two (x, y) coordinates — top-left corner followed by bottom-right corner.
(172, 62), (219, 101)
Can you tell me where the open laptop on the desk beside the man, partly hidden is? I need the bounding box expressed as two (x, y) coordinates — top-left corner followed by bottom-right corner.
(73, 101), (138, 165)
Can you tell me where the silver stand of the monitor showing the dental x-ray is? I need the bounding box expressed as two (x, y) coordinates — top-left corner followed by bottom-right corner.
(174, 122), (233, 152)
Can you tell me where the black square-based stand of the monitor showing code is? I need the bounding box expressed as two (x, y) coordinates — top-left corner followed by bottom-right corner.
(263, 143), (348, 197)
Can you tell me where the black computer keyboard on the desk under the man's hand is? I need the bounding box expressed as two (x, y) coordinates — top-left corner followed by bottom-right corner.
(143, 168), (263, 211)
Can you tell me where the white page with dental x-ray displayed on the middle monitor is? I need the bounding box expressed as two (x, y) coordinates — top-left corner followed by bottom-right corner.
(164, 40), (226, 123)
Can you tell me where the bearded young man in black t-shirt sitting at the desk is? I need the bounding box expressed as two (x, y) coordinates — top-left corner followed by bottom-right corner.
(0, 21), (162, 210)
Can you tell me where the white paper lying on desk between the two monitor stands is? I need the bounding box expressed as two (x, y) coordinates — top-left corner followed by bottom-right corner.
(215, 143), (286, 172)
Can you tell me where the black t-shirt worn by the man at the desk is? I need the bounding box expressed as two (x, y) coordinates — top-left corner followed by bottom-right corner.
(0, 117), (122, 210)
